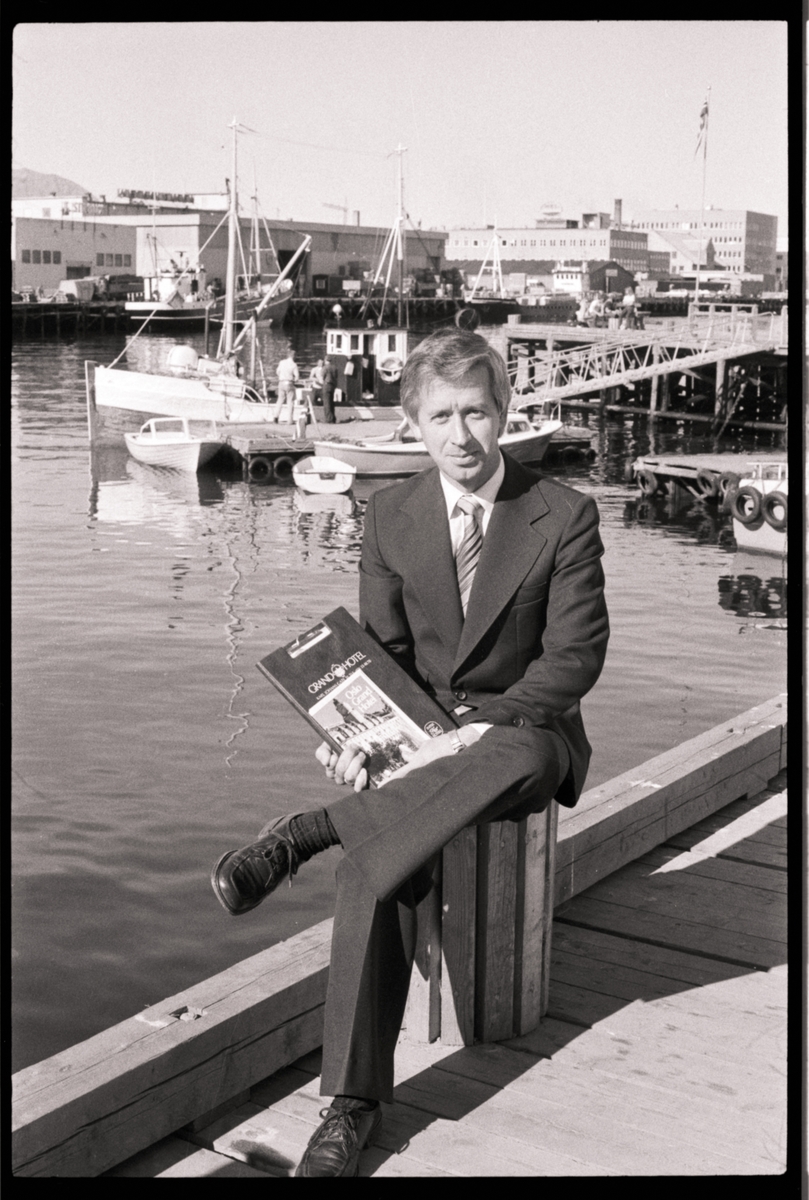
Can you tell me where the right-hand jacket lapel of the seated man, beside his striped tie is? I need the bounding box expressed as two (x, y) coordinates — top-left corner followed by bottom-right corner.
(453, 457), (549, 671)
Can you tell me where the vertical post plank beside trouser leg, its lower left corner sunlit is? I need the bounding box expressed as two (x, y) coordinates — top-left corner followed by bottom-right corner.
(441, 828), (478, 1045)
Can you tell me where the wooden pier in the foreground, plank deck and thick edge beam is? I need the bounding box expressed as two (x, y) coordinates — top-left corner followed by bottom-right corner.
(12, 695), (787, 1177)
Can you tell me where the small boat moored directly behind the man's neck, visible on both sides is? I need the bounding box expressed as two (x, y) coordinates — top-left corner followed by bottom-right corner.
(314, 413), (562, 476)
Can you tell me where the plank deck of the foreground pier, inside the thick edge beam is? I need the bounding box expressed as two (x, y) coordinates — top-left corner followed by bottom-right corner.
(103, 775), (786, 1177)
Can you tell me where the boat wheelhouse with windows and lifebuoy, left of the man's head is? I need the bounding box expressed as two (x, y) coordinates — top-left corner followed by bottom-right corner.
(325, 325), (409, 407)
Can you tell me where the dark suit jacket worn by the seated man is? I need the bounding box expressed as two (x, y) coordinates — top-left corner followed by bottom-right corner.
(360, 454), (609, 808)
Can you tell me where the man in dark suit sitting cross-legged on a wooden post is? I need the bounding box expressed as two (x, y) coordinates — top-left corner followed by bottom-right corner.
(211, 329), (609, 1176)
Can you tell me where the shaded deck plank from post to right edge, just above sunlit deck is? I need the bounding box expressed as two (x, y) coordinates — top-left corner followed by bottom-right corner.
(557, 895), (786, 968)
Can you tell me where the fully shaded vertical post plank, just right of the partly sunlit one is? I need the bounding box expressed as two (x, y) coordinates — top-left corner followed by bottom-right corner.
(475, 821), (517, 1042)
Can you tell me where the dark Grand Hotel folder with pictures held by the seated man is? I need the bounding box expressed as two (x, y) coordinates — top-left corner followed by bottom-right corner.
(258, 608), (455, 787)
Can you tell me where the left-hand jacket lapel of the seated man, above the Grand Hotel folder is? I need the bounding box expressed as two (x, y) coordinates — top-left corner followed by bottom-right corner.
(401, 469), (463, 655)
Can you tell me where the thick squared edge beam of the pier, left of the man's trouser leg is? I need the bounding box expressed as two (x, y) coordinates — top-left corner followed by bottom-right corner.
(12, 920), (331, 1176)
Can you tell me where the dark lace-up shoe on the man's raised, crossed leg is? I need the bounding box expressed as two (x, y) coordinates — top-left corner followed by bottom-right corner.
(211, 814), (299, 917)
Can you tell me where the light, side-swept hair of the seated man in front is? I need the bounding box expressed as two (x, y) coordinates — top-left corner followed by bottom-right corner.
(398, 329), (511, 425)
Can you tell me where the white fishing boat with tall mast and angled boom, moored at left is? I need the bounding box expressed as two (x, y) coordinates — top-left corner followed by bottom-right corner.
(85, 119), (312, 439)
